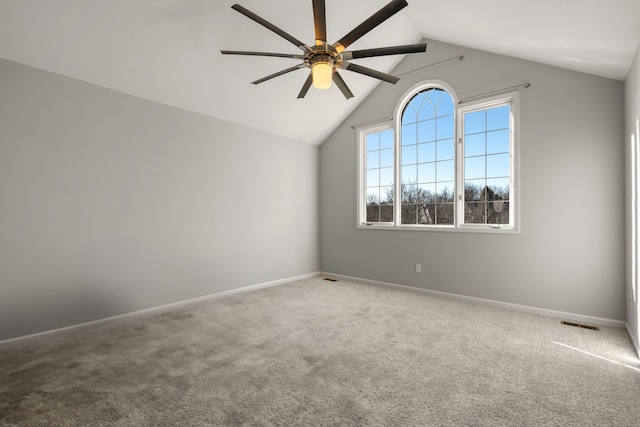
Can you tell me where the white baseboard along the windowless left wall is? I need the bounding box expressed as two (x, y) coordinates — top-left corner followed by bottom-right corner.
(0, 272), (320, 350)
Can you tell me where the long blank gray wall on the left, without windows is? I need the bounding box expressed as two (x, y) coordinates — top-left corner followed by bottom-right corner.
(0, 60), (319, 340)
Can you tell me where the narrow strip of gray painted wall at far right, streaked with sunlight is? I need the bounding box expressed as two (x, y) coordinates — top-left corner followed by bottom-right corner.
(625, 42), (640, 354)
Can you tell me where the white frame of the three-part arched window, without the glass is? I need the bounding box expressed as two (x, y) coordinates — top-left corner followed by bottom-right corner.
(356, 79), (520, 234)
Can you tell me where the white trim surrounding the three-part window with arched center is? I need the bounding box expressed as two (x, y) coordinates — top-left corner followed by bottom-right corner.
(355, 80), (520, 234)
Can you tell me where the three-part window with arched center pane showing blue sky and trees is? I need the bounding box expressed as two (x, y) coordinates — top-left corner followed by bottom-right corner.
(358, 82), (517, 232)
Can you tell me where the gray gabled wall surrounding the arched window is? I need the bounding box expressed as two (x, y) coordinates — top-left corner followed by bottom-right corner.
(320, 41), (625, 320)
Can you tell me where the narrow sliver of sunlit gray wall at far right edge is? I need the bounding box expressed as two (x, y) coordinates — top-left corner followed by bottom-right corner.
(625, 42), (640, 353)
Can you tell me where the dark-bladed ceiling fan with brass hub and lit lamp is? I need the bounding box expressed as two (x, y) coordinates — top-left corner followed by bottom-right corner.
(220, 0), (427, 99)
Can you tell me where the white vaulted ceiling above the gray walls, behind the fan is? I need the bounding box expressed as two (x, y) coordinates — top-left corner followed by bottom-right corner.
(0, 0), (640, 144)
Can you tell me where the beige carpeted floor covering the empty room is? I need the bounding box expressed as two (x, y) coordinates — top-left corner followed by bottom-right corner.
(0, 278), (640, 426)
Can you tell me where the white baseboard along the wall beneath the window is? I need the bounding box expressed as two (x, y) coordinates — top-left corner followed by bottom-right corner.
(320, 272), (624, 330)
